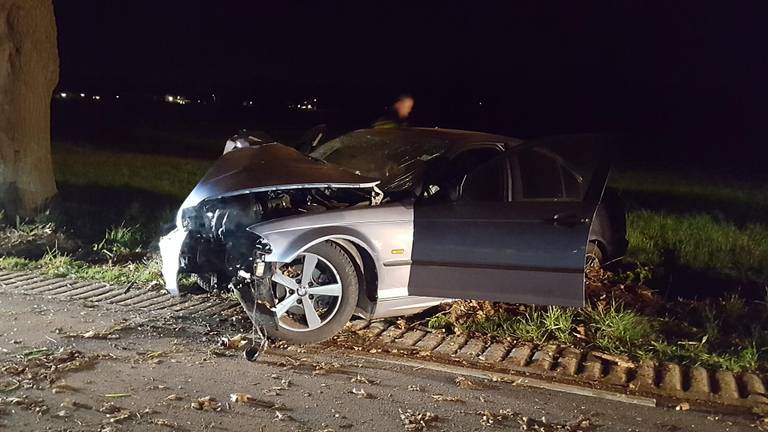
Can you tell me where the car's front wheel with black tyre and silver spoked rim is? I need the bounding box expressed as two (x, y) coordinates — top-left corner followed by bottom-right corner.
(268, 242), (358, 343)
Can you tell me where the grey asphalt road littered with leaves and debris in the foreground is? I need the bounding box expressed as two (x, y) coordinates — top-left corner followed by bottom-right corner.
(0, 291), (757, 432)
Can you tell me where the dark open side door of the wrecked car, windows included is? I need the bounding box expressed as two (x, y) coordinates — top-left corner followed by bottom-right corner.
(408, 138), (608, 306)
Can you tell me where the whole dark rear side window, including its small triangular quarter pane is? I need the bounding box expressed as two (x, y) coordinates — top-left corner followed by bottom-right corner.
(517, 149), (583, 200)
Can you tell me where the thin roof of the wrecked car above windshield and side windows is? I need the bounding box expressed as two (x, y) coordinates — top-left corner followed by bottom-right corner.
(340, 127), (523, 152)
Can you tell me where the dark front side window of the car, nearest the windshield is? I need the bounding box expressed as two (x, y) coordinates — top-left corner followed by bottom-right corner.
(461, 156), (508, 202)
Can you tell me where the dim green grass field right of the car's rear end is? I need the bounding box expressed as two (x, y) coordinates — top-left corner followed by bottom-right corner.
(611, 170), (768, 285)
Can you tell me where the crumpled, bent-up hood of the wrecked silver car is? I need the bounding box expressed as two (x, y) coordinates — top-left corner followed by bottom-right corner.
(181, 143), (379, 208)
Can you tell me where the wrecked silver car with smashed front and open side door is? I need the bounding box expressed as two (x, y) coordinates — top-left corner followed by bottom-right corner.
(160, 128), (627, 343)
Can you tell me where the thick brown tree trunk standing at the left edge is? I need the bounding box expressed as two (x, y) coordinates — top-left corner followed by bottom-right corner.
(0, 0), (59, 216)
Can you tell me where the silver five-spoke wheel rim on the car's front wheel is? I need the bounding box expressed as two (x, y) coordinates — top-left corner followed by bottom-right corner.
(272, 252), (342, 332)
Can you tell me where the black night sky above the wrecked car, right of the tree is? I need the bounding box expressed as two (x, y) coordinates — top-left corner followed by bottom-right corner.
(53, 0), (768, 170)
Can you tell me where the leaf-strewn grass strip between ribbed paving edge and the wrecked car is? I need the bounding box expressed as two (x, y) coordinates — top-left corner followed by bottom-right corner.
(444, 301), (768, 372)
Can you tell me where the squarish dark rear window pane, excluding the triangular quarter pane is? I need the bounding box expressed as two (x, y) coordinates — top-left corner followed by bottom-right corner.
(517, 150), (563, 199)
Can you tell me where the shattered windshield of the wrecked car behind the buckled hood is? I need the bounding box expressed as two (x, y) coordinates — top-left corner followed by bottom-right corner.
(310, 129), (448, 191)
